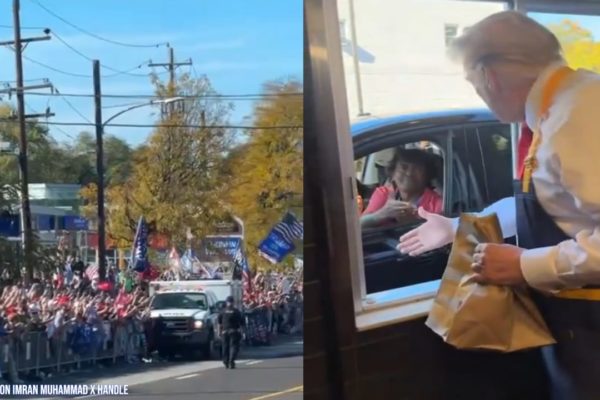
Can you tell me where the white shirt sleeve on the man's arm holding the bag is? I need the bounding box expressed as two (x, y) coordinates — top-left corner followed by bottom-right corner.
(521, 85), (600, 292)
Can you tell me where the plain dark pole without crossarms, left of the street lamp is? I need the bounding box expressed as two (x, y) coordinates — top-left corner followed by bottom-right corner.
(93, 60), (106, 281)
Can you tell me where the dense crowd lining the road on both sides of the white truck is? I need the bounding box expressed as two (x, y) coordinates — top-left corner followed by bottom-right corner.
(0, 262), (302, 382)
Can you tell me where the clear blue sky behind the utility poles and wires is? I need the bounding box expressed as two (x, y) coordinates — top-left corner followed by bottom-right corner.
(0, 0), (303, 145)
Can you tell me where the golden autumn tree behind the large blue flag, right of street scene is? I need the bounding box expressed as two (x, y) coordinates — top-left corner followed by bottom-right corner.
(227, 80), (303, 269)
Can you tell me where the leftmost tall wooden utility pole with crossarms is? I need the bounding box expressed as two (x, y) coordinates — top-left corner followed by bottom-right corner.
(0, 0), (51, 282)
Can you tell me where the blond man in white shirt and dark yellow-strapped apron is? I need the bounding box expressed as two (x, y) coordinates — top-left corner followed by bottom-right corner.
(399, 11), (600, 400)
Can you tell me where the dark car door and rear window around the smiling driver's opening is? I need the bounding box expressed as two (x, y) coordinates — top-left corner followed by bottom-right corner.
(354, 121), (512, 294)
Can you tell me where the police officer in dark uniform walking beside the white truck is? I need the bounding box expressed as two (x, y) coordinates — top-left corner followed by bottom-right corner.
(219, 296), (245, 369)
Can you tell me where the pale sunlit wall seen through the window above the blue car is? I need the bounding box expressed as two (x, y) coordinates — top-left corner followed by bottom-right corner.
(338, 0), (505, 120)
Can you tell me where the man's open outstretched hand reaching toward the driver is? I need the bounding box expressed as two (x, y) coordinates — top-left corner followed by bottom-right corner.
(397, 207), (454, 257)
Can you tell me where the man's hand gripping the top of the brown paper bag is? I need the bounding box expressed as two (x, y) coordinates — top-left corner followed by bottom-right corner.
(471, 243), (526, 286)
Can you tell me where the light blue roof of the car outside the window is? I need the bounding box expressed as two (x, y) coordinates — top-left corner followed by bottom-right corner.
(351, 109), (497, 138)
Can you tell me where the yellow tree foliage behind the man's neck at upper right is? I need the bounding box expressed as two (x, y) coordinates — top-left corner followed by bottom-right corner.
(548, 19), (600, 72)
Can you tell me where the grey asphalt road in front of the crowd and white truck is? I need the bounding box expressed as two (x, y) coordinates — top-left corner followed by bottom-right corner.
(9, 337), (303, 400)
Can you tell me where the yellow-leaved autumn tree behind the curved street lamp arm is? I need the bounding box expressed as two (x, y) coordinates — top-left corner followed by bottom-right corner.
(82, 74), (232, 246)
